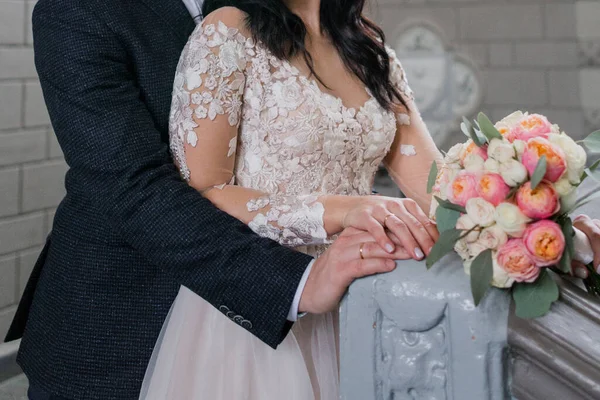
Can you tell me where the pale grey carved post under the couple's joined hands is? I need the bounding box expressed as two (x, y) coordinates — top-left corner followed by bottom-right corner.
(340, 255), (509, 400)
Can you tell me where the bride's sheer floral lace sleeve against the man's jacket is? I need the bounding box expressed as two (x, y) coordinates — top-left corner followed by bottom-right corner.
(170, 7), (327, 246)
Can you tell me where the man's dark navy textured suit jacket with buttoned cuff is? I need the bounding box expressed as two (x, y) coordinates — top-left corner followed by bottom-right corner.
(9, 0), (311, 400)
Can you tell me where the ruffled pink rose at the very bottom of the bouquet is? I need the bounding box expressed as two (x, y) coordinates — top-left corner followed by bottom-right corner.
(497, 239), (540, 282)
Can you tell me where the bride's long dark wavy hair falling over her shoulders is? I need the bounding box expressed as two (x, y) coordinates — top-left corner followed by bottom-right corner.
(202, 0), (408, 110)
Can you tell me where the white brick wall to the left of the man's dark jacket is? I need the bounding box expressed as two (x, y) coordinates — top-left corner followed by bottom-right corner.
(0, 0), (66, 341)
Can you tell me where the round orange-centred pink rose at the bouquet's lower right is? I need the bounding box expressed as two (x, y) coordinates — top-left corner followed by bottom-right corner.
(523, 220), (565, 267)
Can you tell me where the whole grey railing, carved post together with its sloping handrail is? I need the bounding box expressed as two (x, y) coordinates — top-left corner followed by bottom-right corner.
(340, 255), (600, 400)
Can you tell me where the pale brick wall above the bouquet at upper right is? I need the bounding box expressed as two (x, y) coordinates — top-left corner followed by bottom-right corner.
(371, 0), (588, 136)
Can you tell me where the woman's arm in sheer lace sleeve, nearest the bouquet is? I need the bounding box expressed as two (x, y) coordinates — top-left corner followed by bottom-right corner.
(384, 49), (441, 213)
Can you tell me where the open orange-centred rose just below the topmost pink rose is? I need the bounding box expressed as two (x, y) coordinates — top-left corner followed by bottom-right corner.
(521, 137), (567, 182)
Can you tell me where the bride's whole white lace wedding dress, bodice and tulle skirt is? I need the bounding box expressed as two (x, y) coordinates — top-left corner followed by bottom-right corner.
(140, 10), (412, 400)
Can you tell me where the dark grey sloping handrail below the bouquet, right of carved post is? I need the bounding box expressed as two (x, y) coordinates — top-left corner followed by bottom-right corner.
(508, 278), (600, 400)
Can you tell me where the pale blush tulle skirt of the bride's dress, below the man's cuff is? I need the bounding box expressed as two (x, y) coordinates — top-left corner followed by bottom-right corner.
(140, 286), (339, 400)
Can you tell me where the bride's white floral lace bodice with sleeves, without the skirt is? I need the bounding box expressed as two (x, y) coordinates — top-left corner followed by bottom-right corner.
(169, 14), (412, 253)
